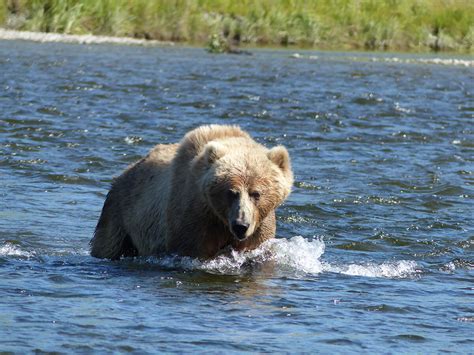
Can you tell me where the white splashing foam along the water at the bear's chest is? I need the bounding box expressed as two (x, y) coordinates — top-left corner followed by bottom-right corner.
(145, 236), (420, 278)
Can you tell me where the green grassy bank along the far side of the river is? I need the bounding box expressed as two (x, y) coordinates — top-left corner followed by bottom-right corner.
(0, 0), (474, 52)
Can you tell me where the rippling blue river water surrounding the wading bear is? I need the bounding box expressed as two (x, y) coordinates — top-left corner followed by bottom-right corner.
(0, 41), (474, 353)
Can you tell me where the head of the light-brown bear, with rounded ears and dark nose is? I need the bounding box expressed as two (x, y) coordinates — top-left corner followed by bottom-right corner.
(192, 137), (293, 241)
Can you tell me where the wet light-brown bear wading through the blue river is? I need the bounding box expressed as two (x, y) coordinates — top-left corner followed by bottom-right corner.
(91, 125), (293, 259)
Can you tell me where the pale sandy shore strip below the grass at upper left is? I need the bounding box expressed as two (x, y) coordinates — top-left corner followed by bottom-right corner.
(0, 28), (174, 46)
